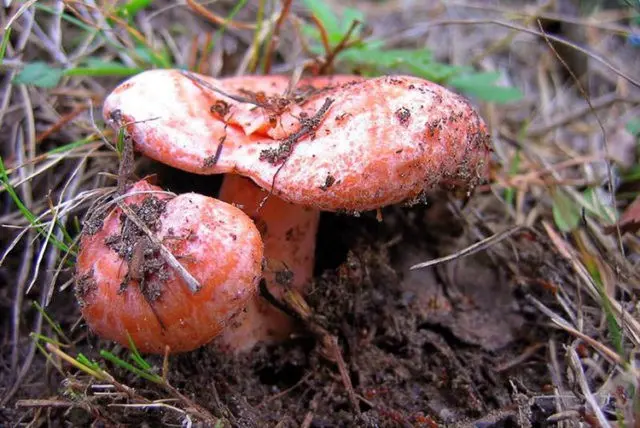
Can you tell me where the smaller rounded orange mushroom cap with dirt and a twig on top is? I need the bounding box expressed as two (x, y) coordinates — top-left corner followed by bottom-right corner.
(76, 181), (263, 353)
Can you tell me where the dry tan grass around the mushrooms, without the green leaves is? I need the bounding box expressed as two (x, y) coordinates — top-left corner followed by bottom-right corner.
(0, 0), (640, 426)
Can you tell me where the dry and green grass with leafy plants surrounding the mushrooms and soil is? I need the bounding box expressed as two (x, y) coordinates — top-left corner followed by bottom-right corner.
(0, 0), (640, 426)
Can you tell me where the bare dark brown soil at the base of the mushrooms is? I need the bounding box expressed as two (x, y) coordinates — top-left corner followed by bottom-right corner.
(164, 176), (552, 427)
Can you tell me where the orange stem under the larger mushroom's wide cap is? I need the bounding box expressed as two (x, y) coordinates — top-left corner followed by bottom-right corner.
(216, 174), (320, 353)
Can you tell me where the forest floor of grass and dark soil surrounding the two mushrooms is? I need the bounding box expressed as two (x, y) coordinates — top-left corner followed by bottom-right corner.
(0, 0), (640, 427)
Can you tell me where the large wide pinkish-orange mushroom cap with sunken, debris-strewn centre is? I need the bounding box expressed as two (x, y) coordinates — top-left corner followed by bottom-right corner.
(103, 70), (491, 212)
